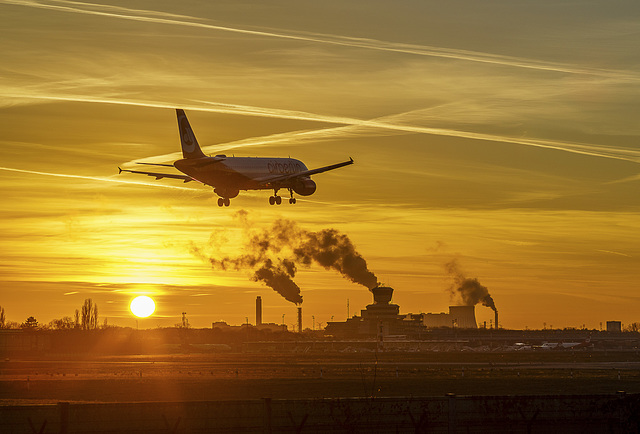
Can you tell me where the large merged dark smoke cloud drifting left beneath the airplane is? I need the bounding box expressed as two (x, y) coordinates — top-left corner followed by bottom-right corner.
(202, 211), (378, 304)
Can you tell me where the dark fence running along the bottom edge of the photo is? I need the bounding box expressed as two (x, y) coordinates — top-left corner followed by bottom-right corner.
(0, 393), (640, 434)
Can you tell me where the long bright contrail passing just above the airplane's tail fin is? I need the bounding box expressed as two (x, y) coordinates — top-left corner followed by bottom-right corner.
(6, 93), (640, 163)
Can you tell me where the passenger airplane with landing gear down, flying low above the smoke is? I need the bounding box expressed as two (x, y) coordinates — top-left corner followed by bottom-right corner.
(118, 109), (353, 207)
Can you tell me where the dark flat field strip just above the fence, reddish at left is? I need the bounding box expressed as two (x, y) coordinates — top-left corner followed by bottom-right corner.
(0, 352), (640, 405)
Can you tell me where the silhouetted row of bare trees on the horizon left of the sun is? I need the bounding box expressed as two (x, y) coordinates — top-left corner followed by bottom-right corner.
(0, 298), (101, 330)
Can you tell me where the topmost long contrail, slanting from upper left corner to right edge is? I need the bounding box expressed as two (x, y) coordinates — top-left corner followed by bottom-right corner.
(0, 0), (640, 81)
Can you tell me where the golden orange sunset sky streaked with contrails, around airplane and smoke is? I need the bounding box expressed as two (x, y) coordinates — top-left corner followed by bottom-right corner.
(0, 0), (640, 328)
